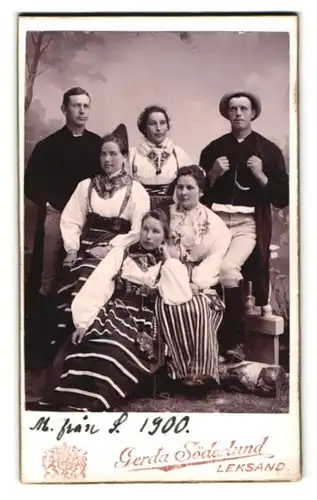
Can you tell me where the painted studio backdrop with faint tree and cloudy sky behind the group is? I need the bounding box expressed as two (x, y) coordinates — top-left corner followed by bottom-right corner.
(25, 28), (289, 364)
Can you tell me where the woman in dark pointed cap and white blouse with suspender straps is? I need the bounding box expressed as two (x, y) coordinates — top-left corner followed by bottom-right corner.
(57, 125), (150, 340)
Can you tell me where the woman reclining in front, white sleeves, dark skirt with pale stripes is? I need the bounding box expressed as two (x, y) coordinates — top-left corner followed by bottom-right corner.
(40, 210), (191, 411)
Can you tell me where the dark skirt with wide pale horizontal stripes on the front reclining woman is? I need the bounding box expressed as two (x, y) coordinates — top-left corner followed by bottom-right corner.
(42, 296), (159, 411)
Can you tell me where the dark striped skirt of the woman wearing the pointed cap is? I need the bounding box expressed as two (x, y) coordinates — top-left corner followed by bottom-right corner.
(56, 217), (129, 342)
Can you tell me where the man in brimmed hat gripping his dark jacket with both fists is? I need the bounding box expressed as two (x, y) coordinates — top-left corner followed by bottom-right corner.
(200, 91), (289, 360)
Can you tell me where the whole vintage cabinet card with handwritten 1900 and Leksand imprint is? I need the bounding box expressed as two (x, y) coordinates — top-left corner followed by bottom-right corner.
(18, 14), (301, 483)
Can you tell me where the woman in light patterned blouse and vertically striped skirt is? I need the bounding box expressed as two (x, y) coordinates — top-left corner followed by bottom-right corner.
(155, 165), (230, 385)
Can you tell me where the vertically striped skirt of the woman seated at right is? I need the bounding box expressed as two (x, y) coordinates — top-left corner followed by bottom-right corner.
(155, 291), (224, 382)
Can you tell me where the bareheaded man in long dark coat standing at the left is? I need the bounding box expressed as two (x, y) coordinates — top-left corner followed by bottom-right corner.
(24, 87), (100, 363)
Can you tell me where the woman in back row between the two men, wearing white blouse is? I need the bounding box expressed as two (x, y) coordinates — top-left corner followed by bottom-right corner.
(129, 105), (192, 213)
